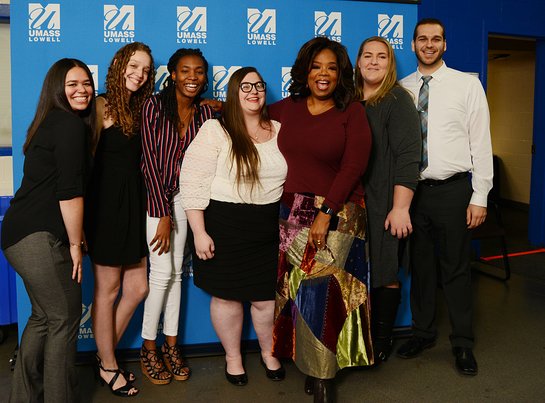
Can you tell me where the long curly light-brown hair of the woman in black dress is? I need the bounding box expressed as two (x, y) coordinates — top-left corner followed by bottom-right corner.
(106, 42), (155, 136)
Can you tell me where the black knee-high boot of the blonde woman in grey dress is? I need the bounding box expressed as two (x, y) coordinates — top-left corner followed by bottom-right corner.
(371, 287), (401, 364)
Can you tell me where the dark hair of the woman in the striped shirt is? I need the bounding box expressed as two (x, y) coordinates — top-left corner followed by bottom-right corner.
(159, 48), (208, 128)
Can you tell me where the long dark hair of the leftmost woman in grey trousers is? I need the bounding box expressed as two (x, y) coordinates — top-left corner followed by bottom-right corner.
(23, 58), (96, 153)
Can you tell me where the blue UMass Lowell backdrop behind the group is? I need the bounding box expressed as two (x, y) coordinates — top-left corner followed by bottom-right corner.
(11, 0), (417, 351)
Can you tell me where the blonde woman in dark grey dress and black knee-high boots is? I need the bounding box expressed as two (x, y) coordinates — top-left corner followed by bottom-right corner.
(355, 36), (421, 363)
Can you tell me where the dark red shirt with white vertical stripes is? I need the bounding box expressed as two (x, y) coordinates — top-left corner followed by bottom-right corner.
(141, 95), (214, 217)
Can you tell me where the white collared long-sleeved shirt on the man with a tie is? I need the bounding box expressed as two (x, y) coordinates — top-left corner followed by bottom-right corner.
(401, 63), (494, 207)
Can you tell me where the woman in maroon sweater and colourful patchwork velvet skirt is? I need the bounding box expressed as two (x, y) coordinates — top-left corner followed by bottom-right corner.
(270, 37), (373, 402)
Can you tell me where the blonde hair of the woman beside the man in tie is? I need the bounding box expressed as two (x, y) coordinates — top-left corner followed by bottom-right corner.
(354, 36), (398, 105)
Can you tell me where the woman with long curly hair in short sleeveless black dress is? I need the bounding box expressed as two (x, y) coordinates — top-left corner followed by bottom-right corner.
(85, 42), (155, 396)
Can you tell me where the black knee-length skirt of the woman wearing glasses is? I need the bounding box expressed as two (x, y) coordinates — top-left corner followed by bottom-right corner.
(193, 200), (279, 301)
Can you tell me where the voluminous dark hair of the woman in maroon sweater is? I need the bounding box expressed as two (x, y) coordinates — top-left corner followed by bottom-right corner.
(289, 37), (354, 110)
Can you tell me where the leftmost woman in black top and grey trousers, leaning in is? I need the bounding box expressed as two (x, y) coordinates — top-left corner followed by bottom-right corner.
(2, 59), (96, 403)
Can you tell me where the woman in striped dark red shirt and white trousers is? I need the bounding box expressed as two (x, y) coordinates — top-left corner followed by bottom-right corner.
(140, 48), (213, 385)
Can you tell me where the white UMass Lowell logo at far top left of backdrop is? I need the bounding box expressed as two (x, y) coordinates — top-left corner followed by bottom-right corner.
(28, 3), (61, 42)
